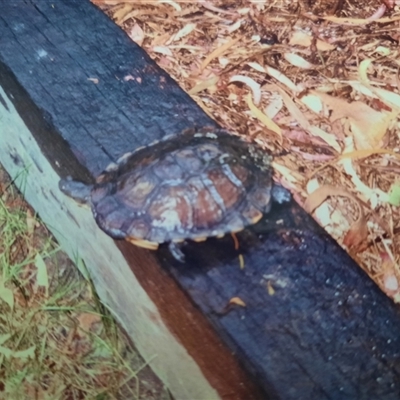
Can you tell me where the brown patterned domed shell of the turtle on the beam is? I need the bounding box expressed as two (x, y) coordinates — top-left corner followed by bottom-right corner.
(90, 129), (272, 249)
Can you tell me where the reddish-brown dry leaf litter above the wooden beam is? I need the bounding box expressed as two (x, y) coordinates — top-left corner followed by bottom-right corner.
(92, 0), (400, 302)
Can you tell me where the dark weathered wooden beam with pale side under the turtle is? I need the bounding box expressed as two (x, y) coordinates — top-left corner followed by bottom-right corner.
(0, 0), (400, 400)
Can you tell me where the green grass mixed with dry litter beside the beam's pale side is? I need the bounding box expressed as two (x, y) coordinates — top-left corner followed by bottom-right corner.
(0, 166), (170, 400)
